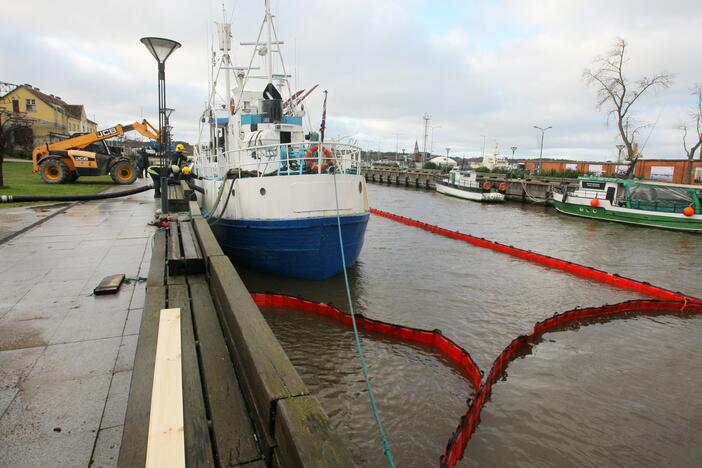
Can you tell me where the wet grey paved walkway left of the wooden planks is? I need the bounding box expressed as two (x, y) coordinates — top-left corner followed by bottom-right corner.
(0, 187), (155, 467)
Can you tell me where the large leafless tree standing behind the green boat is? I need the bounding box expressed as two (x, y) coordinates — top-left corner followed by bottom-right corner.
(583, 38), (673, 177)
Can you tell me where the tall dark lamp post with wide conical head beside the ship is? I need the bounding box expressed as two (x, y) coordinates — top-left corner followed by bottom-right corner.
(141, 37), (180, 213)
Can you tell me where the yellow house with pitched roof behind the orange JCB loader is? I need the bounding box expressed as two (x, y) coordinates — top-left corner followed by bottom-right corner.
(0, 84), (97, 146)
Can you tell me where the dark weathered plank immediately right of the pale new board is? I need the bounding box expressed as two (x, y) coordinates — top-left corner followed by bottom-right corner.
(168, 285), (214, 467)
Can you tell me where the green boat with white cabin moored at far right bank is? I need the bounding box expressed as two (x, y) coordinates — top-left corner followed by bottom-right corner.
(553, 177), (702, 232)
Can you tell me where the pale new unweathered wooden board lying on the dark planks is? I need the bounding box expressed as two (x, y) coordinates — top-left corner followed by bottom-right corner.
(146, 309), (185, 468)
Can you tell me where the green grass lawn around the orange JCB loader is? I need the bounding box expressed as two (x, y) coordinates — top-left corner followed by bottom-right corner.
(0, 161), (115, 208)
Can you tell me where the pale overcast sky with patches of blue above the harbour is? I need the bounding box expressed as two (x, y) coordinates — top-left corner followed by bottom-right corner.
(0, 0), (702, 160)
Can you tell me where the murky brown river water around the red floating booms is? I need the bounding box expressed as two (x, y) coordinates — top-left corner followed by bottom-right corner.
(239, 184), (702, 467)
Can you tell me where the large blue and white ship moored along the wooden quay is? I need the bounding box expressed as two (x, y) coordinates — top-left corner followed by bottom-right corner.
(193, 0), (370, 279)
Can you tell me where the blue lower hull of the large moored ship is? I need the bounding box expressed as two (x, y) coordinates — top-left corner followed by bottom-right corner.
(212, 213), (370, 280)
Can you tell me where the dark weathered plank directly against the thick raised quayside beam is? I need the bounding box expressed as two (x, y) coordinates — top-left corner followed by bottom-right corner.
(188, 277), (261, 466)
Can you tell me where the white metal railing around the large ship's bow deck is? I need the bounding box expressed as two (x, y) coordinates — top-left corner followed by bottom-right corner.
(194, 142), (361, 179)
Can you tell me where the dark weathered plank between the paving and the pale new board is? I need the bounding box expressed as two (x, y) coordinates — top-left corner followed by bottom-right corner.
(118, 284), (166, 466)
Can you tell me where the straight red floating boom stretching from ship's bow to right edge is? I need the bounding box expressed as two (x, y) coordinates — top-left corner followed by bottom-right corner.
(370, 208), (702, 302)
